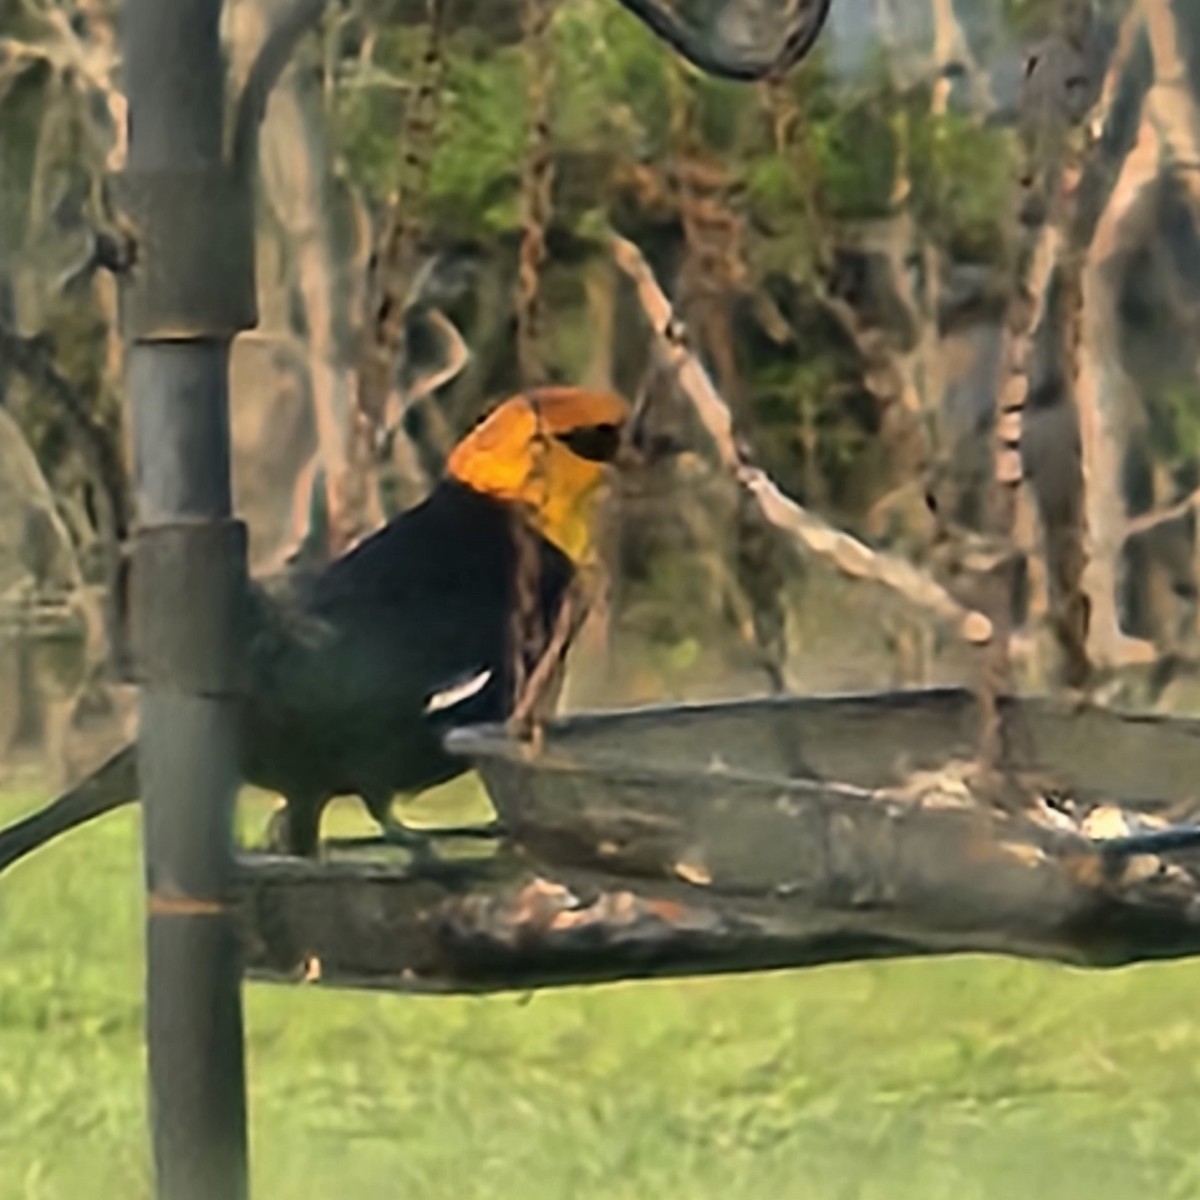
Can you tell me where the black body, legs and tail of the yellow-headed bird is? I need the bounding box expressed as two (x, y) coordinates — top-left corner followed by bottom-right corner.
(0, 479), (574, 870)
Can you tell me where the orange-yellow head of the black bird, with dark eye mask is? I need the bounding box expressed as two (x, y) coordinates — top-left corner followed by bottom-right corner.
(446, 388), (629, 564)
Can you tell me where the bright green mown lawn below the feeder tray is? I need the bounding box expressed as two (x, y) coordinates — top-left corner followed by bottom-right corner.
(0, 768), (1200, 1200)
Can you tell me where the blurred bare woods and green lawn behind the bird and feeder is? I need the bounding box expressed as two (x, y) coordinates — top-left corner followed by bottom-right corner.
(0, 0), (1200, 1200)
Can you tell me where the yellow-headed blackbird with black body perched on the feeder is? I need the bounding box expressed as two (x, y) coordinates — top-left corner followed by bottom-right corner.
(0, 388), (629, 869)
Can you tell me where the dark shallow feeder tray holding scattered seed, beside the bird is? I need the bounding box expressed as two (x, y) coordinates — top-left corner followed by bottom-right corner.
(234, 689), (1200, 991)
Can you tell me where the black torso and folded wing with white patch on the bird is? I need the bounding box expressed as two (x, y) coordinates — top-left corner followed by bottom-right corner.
(237, 485), (571, 791)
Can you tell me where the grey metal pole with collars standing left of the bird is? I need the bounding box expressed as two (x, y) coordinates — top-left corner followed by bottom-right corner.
(114, 0), (256, 1200)
